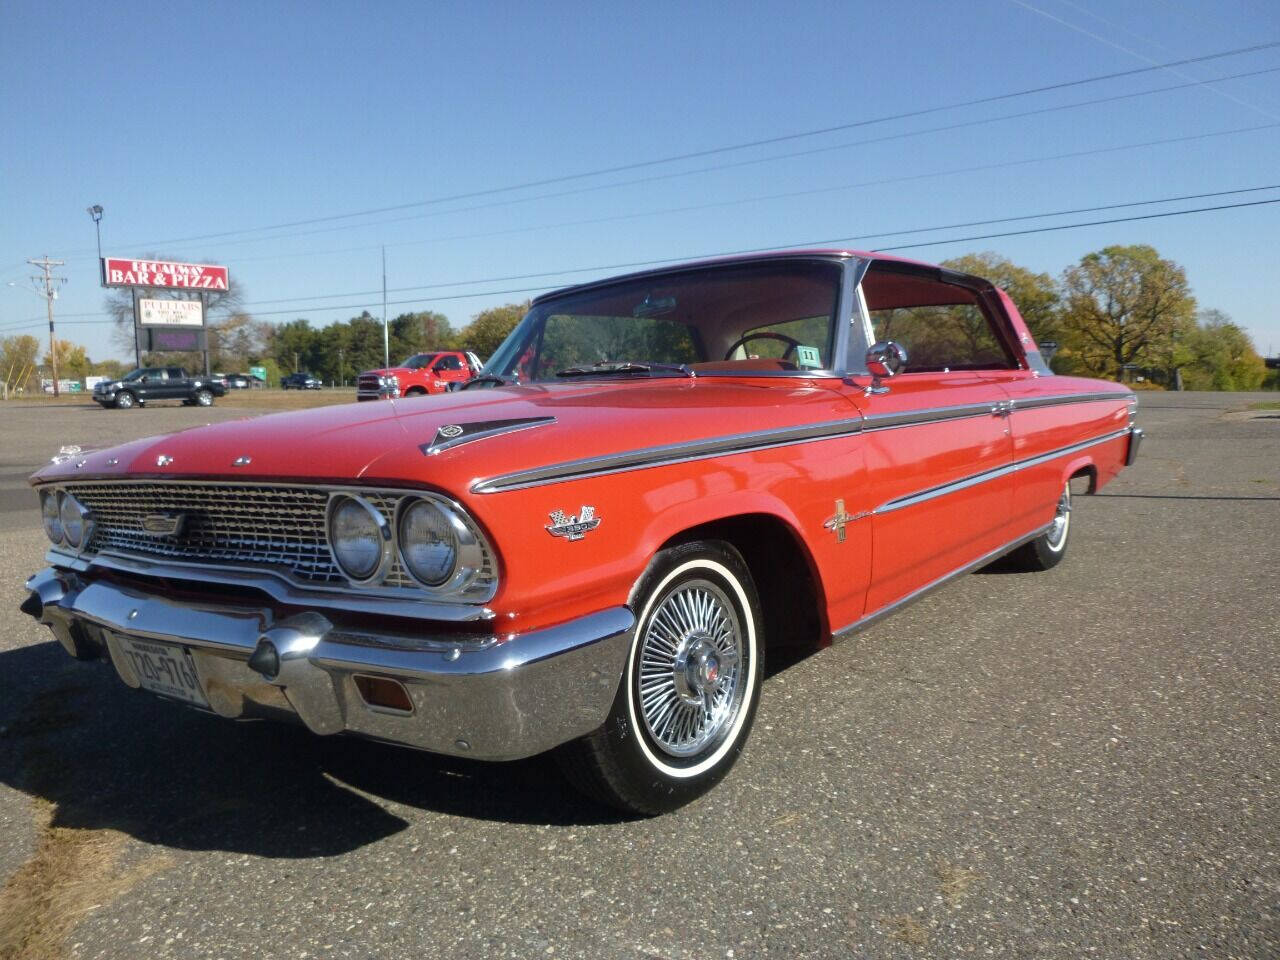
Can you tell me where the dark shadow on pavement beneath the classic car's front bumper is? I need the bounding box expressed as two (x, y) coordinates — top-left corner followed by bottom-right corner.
(0, 643), (621, 858)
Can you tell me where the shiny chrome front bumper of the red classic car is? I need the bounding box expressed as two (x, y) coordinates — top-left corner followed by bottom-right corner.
(23, 568), (635, 760)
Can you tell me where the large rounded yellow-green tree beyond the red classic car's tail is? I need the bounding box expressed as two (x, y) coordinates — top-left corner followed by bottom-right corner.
(1062, 244), (1196, 380)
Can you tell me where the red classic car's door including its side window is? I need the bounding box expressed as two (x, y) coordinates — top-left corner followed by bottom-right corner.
(850, 261), (1020, 614)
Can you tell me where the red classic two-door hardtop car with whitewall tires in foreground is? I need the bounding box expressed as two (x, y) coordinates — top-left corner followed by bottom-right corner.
(23, 251), (1142, 814)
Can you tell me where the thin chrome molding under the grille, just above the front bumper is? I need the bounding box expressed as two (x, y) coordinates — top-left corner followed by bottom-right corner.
(45, 548), (494, 623)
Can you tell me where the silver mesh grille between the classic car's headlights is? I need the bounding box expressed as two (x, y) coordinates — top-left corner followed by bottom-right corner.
(68, 483), (389, 588)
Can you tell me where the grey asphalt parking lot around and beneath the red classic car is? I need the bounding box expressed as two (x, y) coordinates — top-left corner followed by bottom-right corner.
(0, 393), (1280, 960)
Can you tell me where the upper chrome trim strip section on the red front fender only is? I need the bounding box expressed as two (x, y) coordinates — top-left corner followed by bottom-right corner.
(471, 419), (863, 494)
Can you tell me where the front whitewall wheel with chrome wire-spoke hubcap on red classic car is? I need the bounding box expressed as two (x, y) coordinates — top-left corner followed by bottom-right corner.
(558, 540), (764, 815)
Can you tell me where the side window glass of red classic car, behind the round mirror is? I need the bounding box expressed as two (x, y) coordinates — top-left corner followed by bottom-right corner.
(863, 269), (1018, 374)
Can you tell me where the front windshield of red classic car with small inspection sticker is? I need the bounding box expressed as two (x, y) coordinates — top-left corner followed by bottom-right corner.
(484, 260), (840, 383)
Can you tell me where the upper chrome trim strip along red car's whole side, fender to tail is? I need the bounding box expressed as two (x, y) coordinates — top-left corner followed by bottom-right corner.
(471, 393), (1132, 494)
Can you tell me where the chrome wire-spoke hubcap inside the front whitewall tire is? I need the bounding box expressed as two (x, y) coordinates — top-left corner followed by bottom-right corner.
(639, 580), (742, 756)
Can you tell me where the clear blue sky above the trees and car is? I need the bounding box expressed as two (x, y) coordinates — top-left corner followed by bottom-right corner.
(0, 0), (1280, 358)
